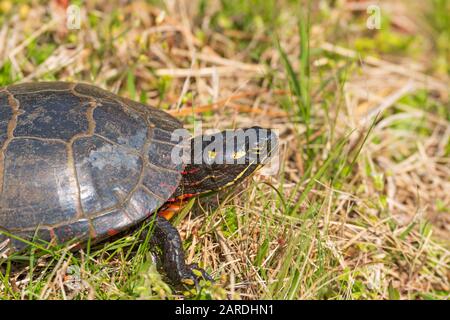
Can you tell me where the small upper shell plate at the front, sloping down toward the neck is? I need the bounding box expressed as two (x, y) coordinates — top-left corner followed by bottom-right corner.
(94, 102), (148, 150)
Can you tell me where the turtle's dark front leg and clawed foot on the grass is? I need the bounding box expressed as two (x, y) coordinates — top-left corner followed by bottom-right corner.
(146, 215), (212, 286)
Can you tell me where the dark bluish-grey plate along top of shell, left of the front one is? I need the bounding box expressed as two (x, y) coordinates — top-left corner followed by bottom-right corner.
(14, 91), (89, 141)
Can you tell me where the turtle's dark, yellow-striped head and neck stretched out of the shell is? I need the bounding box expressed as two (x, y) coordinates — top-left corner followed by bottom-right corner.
(174, 127), (278, 197)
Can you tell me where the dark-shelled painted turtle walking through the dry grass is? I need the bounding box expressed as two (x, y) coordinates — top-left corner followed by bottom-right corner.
(0, 82), (276, 284)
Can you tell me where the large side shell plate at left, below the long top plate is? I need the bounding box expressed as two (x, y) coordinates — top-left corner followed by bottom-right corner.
(0, 138), (77, 229)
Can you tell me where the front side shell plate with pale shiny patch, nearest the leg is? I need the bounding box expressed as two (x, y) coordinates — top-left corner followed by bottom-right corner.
(73, 136), (143, 216)
